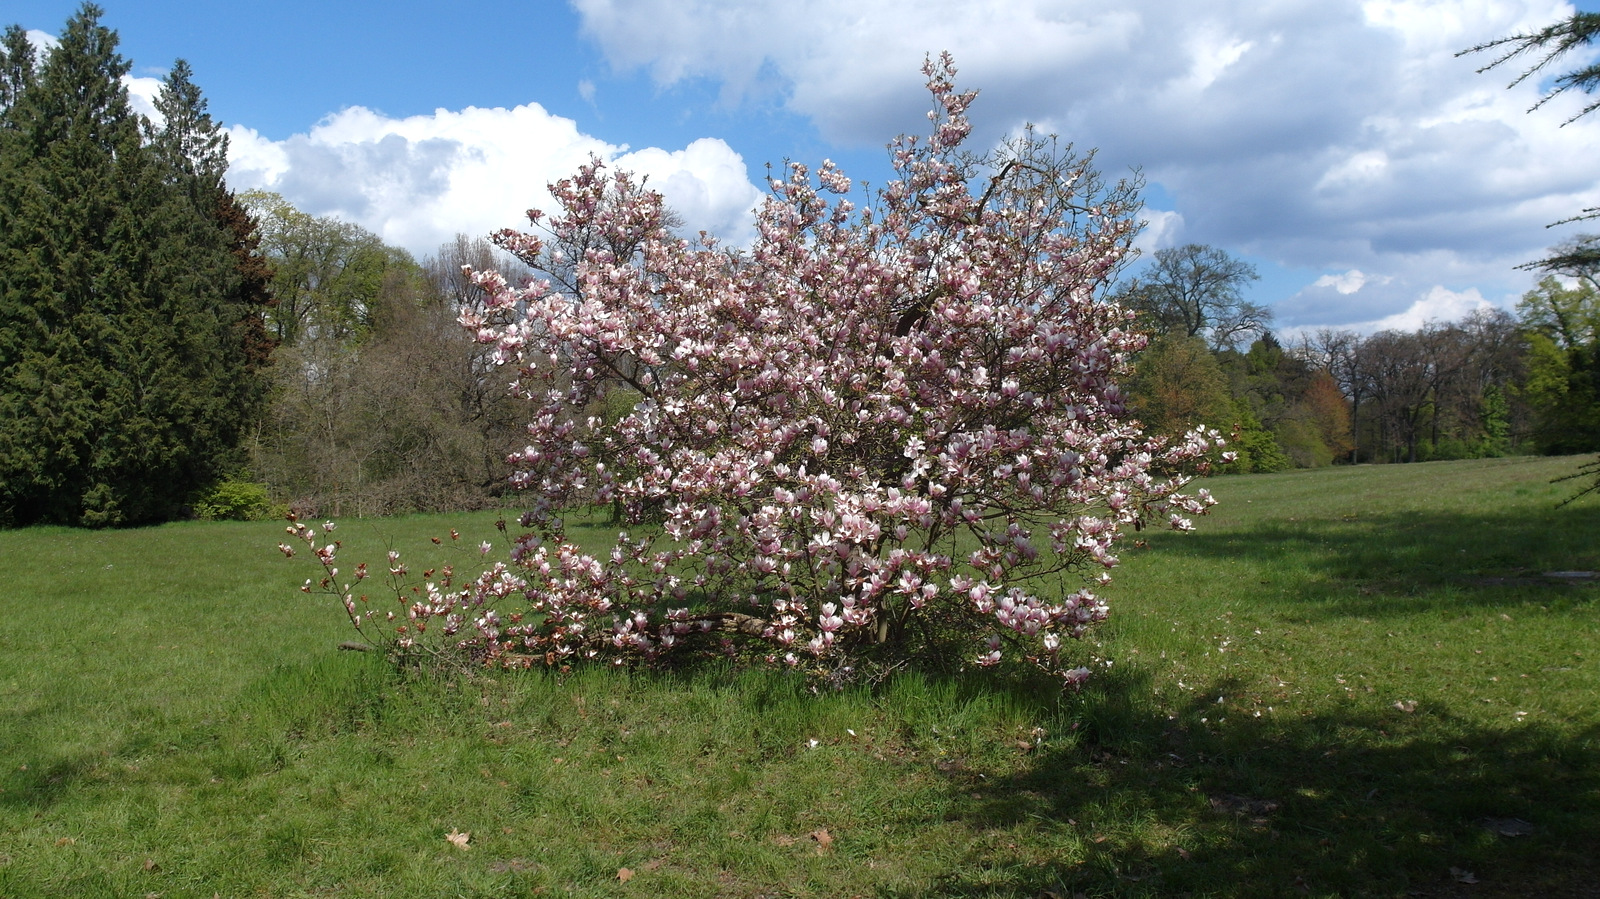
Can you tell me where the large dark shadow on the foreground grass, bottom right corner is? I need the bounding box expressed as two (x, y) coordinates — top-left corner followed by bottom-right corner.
(893, 662), (1600, 899)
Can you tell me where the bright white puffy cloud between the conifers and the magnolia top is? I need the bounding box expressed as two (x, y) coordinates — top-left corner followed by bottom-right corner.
(229, 104), (762, 256)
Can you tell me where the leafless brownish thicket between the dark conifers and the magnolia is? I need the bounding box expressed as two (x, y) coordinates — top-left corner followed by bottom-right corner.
(254, 229), (525, 515)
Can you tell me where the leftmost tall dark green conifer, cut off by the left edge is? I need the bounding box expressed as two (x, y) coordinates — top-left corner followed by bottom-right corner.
(0, 6), (144, 523)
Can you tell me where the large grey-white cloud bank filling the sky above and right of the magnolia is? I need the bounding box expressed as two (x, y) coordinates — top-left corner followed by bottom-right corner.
(573, 0), (1600, 325)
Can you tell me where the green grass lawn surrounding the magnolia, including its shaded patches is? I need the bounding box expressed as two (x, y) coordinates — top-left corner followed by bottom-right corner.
(0, 459), (1600, 899)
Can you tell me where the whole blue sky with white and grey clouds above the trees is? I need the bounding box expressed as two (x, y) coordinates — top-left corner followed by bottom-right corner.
(12, 0), (1600, 330)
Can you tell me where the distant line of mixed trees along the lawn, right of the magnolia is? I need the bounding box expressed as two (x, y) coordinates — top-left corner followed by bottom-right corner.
(1120, 235), (1600, 470)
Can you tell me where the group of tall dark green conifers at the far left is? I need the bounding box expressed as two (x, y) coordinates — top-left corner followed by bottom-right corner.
(0, 5), (272, 526)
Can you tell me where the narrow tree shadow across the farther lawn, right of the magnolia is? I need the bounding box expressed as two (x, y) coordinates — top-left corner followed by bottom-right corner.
(1158, 507), (1600, 616)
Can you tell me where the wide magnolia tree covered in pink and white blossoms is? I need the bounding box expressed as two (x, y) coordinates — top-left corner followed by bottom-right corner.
(291, 56), (1222, 683)
